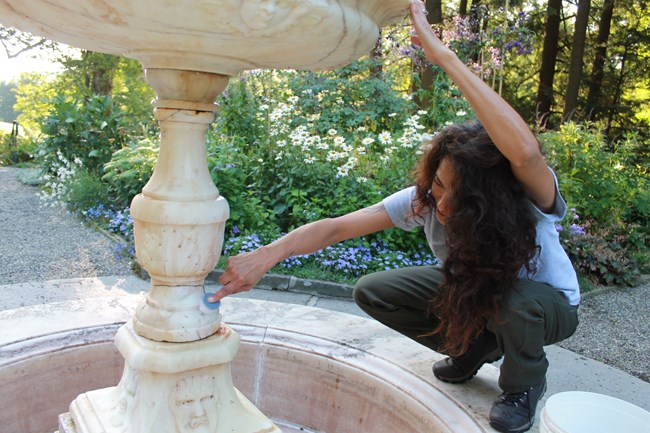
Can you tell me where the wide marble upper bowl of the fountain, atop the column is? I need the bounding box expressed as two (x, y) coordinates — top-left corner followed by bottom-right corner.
(0, 0), (408, 75)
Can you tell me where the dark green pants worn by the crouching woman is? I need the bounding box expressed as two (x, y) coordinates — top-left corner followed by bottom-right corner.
(354, 267), (578, 392)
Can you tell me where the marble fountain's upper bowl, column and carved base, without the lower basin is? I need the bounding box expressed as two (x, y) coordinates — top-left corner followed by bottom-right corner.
(0, 0), (409, 433)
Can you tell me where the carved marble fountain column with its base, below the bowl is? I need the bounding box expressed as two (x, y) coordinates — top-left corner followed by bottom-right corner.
(60, 69), (280, 433)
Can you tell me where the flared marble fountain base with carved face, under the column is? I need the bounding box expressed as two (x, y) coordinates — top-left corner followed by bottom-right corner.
(59, 321), (281, 433)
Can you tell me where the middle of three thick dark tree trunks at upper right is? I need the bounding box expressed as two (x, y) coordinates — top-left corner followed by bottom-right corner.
(562, 0), (591, 122)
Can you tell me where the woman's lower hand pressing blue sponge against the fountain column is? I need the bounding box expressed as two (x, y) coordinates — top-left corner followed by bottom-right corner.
(208, 247), (272, 302)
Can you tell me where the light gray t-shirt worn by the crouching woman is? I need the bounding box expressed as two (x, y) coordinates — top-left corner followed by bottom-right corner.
(383, 168), (580, 305)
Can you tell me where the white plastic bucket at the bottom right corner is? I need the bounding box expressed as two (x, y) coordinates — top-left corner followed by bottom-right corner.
(539, 391), (650, 433)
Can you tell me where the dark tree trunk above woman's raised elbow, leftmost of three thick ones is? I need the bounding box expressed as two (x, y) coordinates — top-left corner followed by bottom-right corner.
(536, 0), (562, 128)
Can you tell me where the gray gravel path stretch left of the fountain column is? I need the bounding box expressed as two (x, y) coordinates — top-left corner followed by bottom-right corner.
(0, 167), (133, 285)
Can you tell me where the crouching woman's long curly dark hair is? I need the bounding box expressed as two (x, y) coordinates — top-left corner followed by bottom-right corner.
(414, 122), (538, 356)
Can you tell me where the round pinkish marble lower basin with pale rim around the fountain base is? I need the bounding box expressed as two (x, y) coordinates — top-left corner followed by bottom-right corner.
(0, 295), (496, 433)
